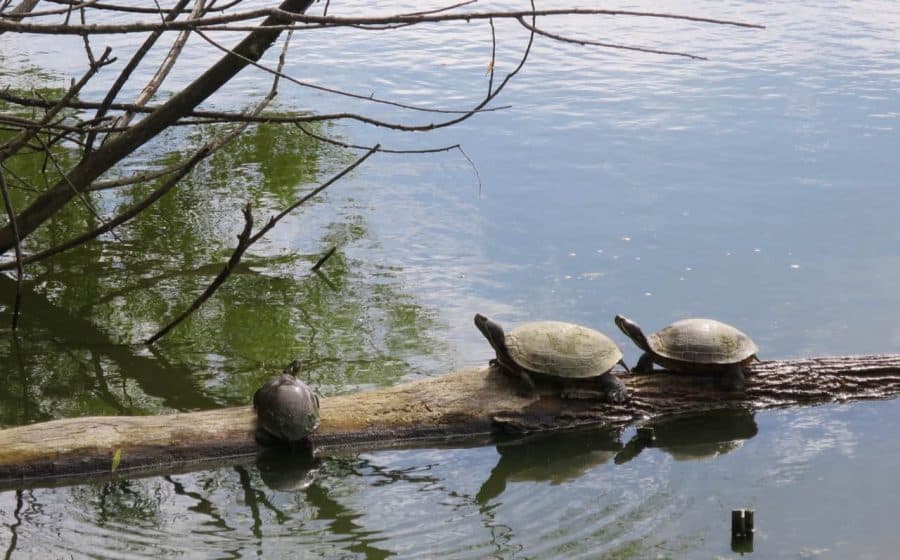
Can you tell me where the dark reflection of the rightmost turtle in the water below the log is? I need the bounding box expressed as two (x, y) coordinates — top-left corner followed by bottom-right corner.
(615, 408), (759, 464)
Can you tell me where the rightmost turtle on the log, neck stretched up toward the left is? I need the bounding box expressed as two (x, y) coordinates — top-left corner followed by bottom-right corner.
(615, 315), (759, 390)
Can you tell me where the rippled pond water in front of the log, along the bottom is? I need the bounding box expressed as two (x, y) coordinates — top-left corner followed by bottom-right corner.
(0, 403), (900, 558)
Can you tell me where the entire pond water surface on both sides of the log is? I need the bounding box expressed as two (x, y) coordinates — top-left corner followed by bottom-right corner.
(0, 0), (900, 558)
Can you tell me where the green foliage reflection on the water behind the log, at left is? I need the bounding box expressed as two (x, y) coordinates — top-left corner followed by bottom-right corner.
(0, 118), (439, 425)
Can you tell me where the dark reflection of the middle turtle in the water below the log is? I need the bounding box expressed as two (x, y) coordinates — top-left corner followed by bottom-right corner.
(475, 429), (622, 504)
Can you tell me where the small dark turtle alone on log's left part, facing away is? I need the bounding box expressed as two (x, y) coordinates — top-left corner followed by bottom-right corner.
(253, 362), (319, 444)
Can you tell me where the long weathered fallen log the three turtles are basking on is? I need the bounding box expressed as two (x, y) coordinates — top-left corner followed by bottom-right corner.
(0, 355), (900, 486)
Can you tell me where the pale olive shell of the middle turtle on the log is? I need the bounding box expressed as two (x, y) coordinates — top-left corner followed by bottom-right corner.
(506, 321), (622, 378)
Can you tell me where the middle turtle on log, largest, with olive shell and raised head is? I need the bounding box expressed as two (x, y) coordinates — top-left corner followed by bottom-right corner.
(475, 313), (628, 403)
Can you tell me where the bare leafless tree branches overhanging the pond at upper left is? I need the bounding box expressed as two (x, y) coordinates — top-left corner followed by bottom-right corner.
(0, 0), (762, 350)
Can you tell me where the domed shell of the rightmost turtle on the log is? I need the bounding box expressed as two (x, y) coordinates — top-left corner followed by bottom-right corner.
(647, 319), (759, 364)
